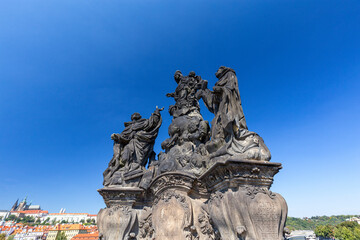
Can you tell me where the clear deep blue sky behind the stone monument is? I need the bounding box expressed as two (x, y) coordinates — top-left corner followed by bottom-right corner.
(0, 0), (360, 217)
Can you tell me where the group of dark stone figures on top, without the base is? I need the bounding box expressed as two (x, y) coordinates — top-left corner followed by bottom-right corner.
(104, 67), (271, 186)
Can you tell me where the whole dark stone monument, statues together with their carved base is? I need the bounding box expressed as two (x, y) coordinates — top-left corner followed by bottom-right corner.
(98, 67), (287, 240)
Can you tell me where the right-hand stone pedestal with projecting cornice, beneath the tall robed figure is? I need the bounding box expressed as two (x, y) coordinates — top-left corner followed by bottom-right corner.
(200, 160), (287, 240)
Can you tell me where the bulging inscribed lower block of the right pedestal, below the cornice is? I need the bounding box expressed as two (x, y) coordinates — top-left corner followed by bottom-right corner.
(209, 186), (287, 240)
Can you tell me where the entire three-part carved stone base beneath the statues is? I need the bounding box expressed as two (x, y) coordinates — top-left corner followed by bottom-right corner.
(98, 159), (287, 240)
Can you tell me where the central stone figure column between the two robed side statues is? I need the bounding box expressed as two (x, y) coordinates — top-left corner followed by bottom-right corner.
(159, 71), (210, 174)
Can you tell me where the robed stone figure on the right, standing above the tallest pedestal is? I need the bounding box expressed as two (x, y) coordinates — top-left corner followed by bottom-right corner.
(197, 66), (271, 161)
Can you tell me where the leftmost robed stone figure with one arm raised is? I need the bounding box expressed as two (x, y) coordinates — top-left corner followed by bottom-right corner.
(103, 107), (164, 186)
